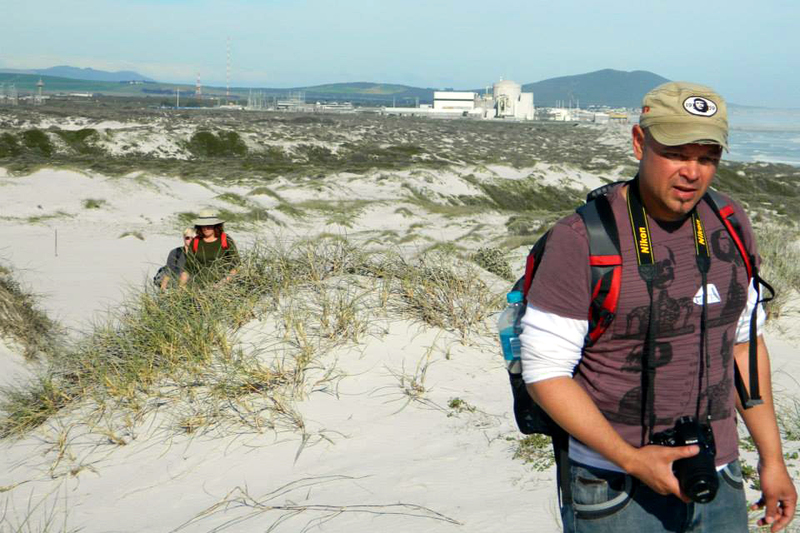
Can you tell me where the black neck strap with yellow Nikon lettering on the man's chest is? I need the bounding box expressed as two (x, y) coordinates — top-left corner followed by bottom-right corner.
(627, 176), (711, 445)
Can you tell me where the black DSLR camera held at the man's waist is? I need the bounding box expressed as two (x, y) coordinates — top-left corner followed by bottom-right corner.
(650, 416), (719, 503)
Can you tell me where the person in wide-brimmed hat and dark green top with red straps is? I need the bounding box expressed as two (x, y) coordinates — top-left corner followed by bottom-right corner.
(180, 209), (239, 286)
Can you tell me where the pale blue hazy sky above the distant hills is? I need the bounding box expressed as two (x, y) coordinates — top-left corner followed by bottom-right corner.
(0, 0), (800, 107)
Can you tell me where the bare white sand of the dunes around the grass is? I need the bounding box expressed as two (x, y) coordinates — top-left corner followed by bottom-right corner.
(0, 167), (800, 533)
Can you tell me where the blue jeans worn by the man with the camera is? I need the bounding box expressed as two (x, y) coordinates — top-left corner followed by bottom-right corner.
(561, 461), (747, 533)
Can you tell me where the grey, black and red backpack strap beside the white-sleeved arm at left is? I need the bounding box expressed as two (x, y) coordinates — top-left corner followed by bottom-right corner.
(578, 191), (622, 346)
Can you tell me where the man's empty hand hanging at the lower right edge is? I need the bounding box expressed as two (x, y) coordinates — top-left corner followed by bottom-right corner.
(750, 461), (797, 533)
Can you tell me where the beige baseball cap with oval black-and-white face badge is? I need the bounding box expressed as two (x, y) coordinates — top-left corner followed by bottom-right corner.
(639, 81), (728, 150)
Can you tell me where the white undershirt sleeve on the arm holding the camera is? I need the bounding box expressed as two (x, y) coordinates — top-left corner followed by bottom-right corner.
(519, 304), (589, 383)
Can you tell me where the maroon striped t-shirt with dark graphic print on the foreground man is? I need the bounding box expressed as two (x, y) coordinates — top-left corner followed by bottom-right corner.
(528, 187), (755, 465)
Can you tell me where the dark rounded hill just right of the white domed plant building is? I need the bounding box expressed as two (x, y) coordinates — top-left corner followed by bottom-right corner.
(522, 69), (669, 108)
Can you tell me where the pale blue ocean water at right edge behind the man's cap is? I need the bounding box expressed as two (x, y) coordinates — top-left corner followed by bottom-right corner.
(723, 107), (800, 166)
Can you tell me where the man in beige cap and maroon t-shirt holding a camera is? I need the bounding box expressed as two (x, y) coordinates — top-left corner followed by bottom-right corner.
(520, 83), (797, 532)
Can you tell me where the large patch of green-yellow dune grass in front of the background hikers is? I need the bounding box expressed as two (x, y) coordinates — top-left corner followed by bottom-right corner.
(0, 236), (500, 437)
